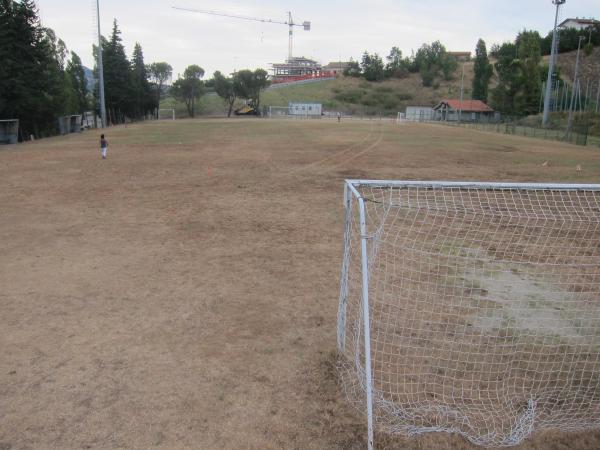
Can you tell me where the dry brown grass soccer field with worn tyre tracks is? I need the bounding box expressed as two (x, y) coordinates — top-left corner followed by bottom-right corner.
(0, 119), (600, 450)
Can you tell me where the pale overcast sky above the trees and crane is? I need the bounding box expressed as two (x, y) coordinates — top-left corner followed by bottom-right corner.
(38, 0), (600, 78)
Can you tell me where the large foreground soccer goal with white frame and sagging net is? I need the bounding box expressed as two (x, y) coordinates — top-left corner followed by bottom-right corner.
(337, 180), (600, 448)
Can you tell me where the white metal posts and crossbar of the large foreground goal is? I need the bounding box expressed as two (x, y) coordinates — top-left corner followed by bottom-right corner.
(337, 179), (600, 450)
